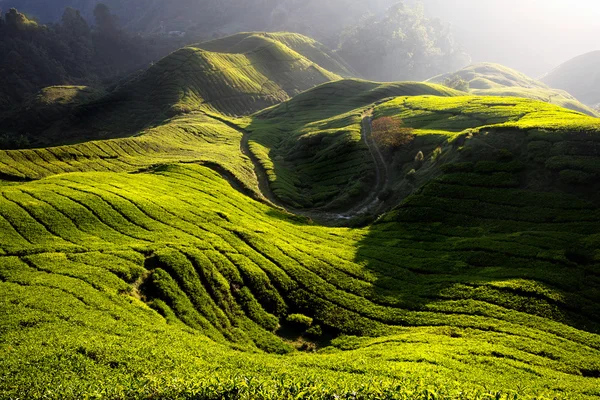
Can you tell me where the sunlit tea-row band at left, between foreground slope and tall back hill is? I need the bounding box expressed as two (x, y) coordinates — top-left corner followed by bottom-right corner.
(0, 113), (258, 192)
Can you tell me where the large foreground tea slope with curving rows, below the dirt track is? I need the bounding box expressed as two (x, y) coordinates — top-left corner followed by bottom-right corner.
(0, 162), (600, 398)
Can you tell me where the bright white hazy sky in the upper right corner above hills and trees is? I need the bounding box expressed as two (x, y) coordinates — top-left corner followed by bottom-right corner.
(422, 0), (600, 77)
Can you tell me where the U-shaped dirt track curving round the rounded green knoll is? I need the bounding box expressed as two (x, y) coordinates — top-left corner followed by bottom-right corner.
(200, 109), (389, 222)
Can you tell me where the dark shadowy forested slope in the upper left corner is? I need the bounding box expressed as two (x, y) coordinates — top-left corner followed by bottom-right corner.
(0, 3), (181, 110)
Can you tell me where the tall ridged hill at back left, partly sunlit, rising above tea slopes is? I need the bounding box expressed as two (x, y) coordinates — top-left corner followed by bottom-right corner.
(1, 34), (348, 147)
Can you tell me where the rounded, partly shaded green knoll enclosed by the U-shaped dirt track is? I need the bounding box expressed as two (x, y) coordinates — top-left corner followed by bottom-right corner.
(241, 80), (460, 209)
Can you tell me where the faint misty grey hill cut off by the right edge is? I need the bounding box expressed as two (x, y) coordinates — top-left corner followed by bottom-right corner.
(542, 51), (600, 105)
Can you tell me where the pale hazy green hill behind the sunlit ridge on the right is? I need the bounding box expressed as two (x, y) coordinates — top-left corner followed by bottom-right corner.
(429, 63), (598, 117)
